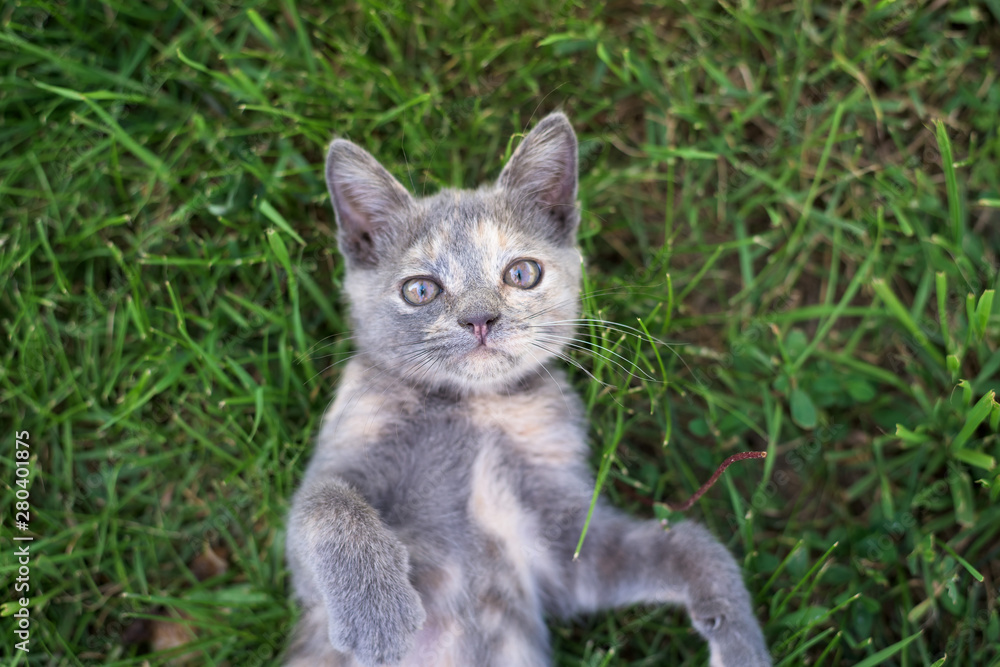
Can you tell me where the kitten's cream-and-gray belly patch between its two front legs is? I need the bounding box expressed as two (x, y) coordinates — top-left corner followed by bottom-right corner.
(394, 440), (552, 667)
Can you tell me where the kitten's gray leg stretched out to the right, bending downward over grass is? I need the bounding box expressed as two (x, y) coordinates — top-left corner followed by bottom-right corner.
(552, 507), (771, 667)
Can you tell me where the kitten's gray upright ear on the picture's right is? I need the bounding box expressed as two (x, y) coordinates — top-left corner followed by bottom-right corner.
(497, 112), (580, 243)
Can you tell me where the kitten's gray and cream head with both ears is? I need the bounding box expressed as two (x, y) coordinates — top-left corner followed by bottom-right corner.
(326, 113), (581, 393)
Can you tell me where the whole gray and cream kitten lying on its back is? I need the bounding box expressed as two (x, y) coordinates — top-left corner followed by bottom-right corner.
(286, 113), (771, 667)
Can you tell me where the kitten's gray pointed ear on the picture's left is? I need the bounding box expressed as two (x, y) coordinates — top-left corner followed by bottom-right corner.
(326, 139), (414, 266)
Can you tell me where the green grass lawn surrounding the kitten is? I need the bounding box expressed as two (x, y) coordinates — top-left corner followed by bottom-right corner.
(0, 0), (1000, 667)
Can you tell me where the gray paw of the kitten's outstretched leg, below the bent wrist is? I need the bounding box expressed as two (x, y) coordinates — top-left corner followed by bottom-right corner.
(690, 600), (771, 667)
